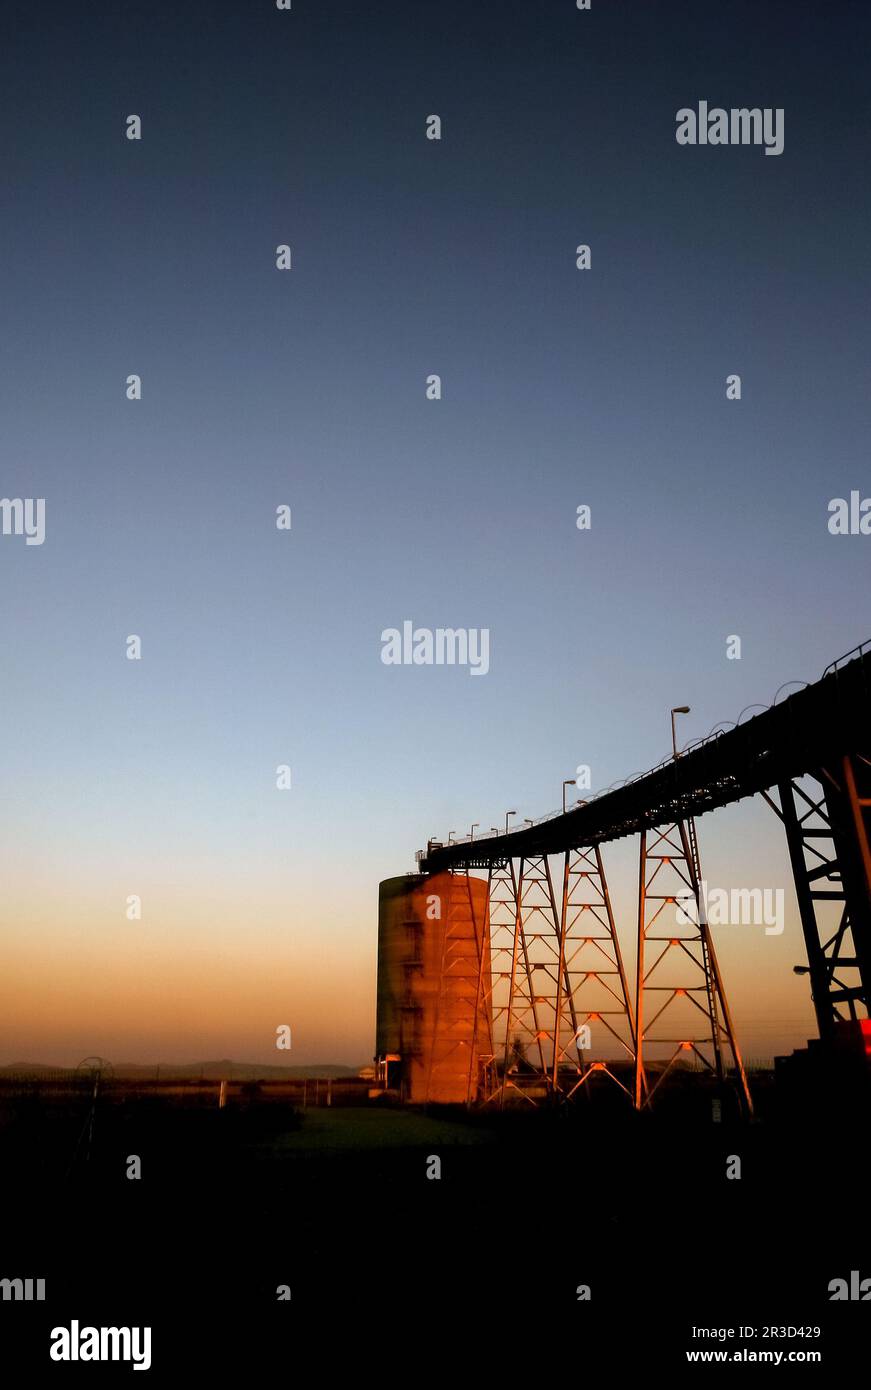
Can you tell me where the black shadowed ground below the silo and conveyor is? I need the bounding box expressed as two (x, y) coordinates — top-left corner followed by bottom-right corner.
(0, 1088), (871, 1367)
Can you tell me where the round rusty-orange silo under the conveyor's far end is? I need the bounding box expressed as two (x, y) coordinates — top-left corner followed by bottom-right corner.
(375, 873), (493, 1104)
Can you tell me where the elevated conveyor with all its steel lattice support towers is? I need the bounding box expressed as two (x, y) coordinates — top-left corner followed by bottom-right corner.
(418, 644), (871, 1111)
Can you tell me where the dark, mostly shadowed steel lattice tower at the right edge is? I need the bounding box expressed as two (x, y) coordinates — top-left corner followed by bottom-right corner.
(765, 755), (871, 1044)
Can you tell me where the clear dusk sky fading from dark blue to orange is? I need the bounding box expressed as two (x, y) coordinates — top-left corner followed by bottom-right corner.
(0, 0), (871, 1065)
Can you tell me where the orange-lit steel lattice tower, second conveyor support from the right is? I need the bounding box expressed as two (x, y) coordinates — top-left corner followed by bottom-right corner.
(635, 820), (753, 1115)
